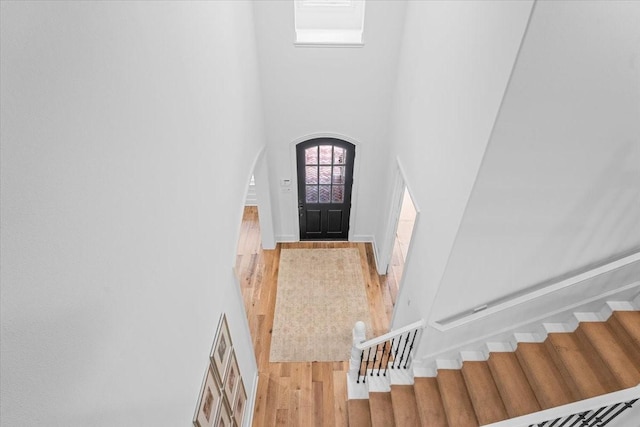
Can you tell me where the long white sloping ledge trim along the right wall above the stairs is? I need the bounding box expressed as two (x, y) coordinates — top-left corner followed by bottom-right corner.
(429, 252), (640, 331)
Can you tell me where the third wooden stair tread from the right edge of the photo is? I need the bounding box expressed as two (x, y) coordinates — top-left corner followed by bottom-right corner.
(545, 333), (608, 399)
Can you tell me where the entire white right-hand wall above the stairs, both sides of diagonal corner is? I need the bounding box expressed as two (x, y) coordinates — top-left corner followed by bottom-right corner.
(393, 1), (640, 358)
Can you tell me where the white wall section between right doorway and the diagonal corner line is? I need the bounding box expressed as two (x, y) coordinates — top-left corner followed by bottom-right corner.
(391, 1), (532, 327)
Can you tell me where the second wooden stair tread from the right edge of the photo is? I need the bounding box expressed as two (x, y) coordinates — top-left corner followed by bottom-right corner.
(578, 322), (640, 389)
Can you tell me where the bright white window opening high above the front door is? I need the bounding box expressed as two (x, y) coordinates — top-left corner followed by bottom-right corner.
(294, 0), (365, 46)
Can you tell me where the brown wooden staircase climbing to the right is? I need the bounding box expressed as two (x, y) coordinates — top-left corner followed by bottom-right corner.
(347, 303), (640, 427)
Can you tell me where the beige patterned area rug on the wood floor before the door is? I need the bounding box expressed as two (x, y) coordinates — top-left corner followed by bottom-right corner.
(269, 248), (372, 362)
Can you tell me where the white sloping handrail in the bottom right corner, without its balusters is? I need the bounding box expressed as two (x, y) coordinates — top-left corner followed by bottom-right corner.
(484, 385), (640, 427)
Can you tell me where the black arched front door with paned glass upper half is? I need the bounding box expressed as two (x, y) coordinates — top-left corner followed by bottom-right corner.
(296, 138), (356, 240)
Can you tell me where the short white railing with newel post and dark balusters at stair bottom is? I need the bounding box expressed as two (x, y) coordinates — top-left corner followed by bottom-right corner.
(349, 319), (427, 384)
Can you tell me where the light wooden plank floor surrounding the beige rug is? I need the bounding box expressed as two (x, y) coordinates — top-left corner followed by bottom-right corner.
(236, 207), (398, 427)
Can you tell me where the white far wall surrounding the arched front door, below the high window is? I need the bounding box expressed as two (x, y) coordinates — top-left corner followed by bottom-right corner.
(254, 0), (405, 246)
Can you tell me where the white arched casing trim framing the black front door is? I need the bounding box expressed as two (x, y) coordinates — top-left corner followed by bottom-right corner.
(285, 132), (362, 242)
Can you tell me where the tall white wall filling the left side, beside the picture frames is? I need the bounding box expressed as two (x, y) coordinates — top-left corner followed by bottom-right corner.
(1, 1), (263, 426)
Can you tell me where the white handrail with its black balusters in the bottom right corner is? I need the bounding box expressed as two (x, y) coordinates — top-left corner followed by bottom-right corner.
(484, 386), (640, 427)
